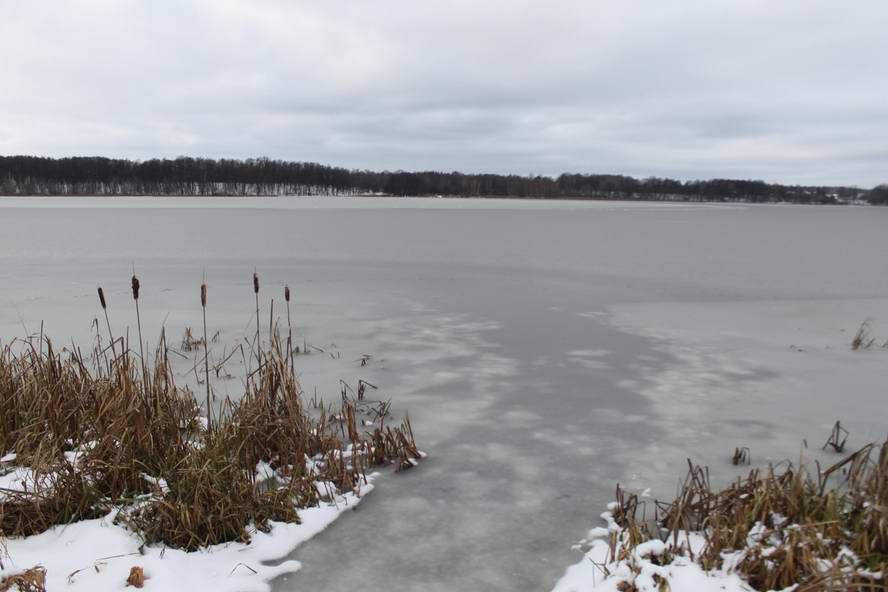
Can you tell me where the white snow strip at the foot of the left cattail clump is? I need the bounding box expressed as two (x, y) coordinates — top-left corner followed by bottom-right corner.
(0, 474), (376, 592)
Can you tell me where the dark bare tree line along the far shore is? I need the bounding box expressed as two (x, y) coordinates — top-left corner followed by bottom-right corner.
(0, 156), (888, 205)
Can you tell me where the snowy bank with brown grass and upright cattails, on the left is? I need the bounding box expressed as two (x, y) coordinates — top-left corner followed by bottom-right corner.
(0, 276), (423, 590)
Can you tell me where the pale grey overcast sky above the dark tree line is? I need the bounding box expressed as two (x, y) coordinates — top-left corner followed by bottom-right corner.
(0, 0), (888, 187)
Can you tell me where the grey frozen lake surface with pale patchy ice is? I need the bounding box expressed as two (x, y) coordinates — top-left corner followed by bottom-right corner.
(0, 198), (888, 592)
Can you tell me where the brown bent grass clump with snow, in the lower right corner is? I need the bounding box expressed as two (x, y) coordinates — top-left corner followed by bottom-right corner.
(610, 441), (888, 591)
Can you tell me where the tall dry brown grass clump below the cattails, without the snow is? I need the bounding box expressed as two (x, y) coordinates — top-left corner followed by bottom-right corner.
(0, 280), (420, 550)
